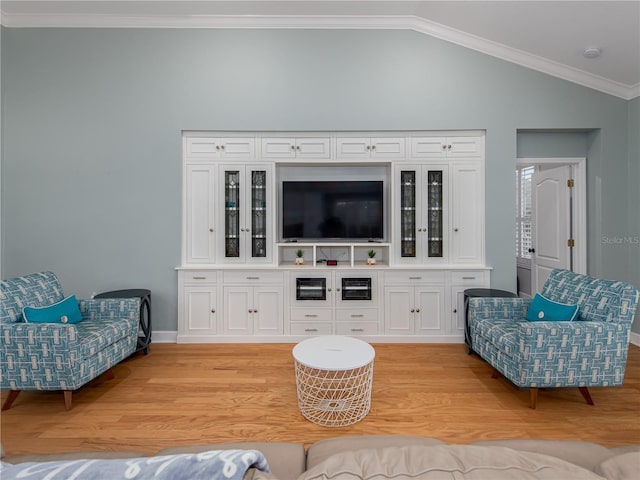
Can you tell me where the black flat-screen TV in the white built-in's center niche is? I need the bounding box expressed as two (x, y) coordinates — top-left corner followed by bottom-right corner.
(282, 181), (384, 240)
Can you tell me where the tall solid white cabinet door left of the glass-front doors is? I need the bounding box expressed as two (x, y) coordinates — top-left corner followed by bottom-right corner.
(183, 164), (217, 264)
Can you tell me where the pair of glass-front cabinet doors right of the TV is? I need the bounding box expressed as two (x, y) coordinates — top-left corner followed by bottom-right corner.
(396, 165), (447, 264)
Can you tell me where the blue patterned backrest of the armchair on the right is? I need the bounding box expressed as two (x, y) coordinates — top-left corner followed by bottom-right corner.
(541, 269), (638, 326)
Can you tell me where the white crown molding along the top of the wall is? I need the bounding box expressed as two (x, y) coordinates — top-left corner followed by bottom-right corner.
(0, 12), (640, 100)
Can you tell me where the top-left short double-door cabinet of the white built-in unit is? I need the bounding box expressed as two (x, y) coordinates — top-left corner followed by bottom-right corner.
(184, 137), (256, 161)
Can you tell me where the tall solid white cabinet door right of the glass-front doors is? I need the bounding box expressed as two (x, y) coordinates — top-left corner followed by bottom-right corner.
(445, 162), (484, 265)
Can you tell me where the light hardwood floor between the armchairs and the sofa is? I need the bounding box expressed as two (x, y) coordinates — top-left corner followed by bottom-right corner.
(2, 344), (640, 454)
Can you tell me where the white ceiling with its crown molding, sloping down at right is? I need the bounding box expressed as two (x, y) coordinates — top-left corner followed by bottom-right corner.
(0, 0), (640, 99)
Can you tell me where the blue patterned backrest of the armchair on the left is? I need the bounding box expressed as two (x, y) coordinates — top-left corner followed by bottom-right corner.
(0, 272), (64, 323)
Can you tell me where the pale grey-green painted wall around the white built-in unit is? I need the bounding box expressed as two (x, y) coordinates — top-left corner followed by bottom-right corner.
(2, 28), (640, 330)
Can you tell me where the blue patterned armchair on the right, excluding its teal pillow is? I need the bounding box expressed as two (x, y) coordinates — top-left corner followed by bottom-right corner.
(469, 270), (638, 408)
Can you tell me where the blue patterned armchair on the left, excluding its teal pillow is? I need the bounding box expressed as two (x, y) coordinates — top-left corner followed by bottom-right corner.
(0, 272), (140, 410)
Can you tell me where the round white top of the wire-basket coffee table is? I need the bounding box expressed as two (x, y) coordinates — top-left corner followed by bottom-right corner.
(293, 335), (376, 370)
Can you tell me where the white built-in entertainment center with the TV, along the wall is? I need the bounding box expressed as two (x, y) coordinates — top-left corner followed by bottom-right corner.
(178, 131), (490, 343)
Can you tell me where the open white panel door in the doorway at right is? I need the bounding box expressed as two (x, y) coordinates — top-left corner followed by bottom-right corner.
(531, 165), (572, 295)
